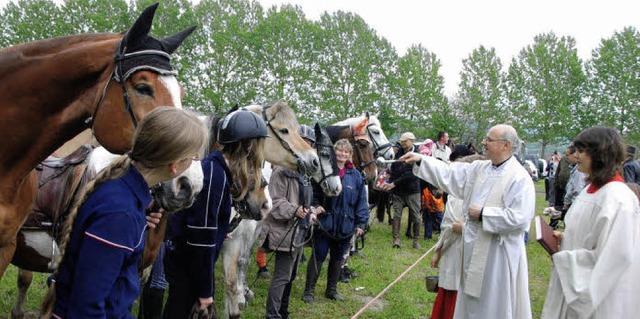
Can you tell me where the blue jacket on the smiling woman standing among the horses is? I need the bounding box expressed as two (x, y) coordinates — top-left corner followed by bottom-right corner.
(311, 168), (369, 240)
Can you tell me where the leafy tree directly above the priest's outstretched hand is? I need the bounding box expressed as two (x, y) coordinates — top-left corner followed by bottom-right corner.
(395, 45), (448, 137)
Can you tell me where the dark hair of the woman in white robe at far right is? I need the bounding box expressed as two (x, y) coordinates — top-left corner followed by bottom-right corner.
(573, 127), (627, 187)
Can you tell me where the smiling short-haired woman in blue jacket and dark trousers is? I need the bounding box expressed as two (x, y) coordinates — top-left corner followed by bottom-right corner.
(302, 139), (369, 303)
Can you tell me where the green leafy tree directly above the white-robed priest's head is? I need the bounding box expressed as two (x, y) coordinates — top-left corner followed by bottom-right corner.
(456, 46), (507, 145)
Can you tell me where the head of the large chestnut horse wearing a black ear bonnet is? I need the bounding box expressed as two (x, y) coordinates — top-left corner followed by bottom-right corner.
(92, 3), (195, 153)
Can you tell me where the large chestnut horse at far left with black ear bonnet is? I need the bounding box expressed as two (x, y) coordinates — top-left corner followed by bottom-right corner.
(0, 4), (194, 278)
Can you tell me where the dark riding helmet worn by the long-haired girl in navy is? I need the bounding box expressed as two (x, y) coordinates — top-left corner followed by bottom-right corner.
(218, 110), (269, 144)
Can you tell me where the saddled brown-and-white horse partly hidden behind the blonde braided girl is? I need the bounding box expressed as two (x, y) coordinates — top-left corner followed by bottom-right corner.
(11, 146), (203, 319)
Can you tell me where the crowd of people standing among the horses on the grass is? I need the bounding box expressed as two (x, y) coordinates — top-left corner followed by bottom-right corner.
(43, 108), (640, 319)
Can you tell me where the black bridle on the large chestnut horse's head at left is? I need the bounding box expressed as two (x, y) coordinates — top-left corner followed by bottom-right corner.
(85, 37), (174, 131)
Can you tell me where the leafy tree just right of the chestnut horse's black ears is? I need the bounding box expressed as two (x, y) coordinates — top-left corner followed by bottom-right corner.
(183, 0), (263, 114)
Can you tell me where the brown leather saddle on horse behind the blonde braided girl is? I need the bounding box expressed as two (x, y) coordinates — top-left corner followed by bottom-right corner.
(22, 144), (94, 230)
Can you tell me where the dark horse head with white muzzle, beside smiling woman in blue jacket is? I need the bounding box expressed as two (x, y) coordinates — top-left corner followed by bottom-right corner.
(311, 123), (342, 196)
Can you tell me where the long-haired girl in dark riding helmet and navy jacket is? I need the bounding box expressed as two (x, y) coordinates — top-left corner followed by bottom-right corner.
(163, 110), (268, 319)
